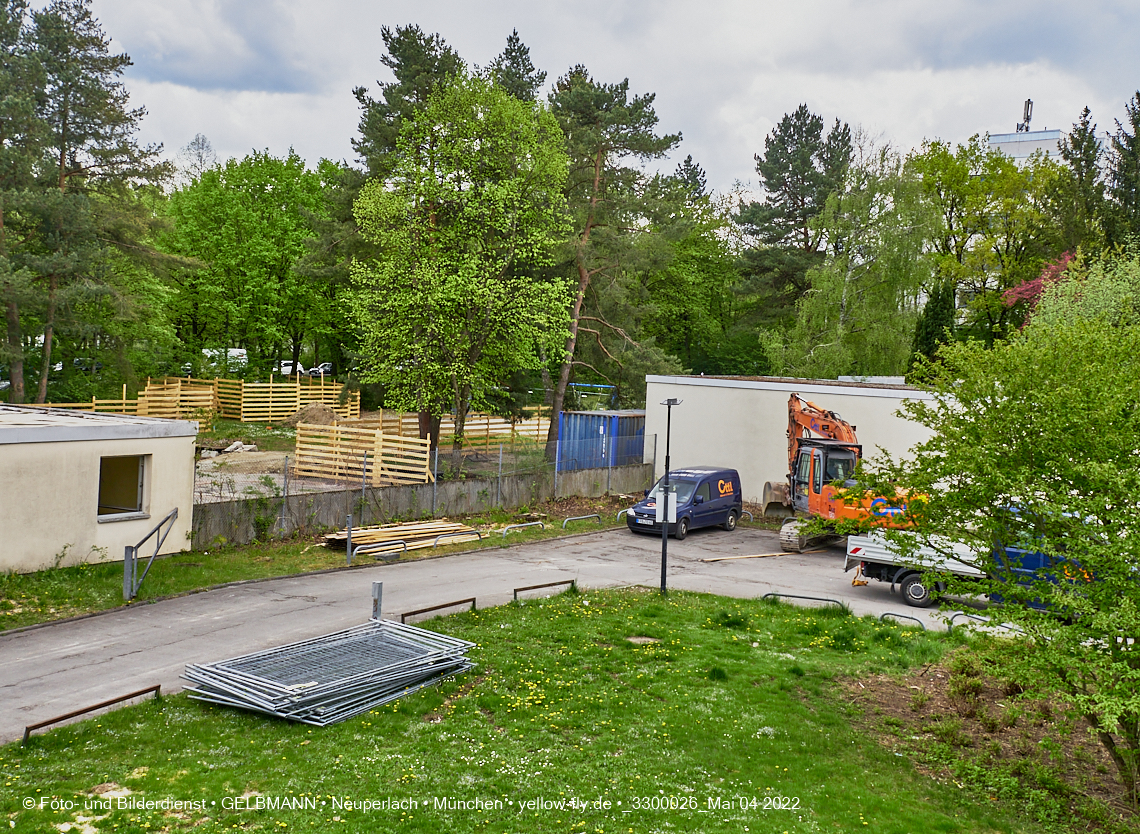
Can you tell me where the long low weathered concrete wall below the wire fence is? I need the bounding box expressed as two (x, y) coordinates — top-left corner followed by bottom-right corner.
(186, 465), (653, 546)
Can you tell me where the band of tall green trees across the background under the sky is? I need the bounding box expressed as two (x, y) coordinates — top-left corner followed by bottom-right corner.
(0, 0), (1140, 448)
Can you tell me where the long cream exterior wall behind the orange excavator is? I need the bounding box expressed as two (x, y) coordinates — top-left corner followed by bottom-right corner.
(645, 376), (930, 502)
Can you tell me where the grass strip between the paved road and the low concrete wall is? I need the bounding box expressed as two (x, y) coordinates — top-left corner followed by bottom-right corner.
(0, 498), (642, 631)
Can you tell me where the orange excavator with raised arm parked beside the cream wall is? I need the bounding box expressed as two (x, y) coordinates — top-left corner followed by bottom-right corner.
(765, 394), (904, 553)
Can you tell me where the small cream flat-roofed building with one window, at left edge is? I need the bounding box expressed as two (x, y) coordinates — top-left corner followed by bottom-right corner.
(0, 404), (197, 572)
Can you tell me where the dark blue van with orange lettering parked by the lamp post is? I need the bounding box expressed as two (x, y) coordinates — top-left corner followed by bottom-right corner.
(626, 466), (744, 540)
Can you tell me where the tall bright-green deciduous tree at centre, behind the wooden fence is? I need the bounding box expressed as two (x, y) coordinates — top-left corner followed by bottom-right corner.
(353, 70), (569, 466)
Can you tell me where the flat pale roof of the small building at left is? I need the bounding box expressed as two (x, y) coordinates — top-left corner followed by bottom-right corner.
(0, 404), (198, 445)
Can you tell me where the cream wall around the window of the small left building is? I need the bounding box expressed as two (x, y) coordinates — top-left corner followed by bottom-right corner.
(0, 436), (194, 572)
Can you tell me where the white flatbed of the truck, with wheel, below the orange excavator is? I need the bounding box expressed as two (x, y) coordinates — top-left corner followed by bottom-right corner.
(844, 533), (985, 608)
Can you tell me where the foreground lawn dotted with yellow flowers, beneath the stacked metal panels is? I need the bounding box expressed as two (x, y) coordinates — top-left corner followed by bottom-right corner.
(0, 590), (1112, 834)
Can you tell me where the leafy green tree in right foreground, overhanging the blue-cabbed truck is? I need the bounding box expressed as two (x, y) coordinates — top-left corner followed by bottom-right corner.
(871, 317), (1140, 802)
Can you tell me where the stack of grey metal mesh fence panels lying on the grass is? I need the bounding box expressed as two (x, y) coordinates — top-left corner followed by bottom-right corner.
(182, 620), (474, 727)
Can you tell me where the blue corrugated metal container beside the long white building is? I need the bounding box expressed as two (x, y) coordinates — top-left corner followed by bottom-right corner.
(559, 410), (645, 472)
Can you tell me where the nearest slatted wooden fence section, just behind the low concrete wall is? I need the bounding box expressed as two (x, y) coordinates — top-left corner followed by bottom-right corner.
(293, 423), (432, 487)
